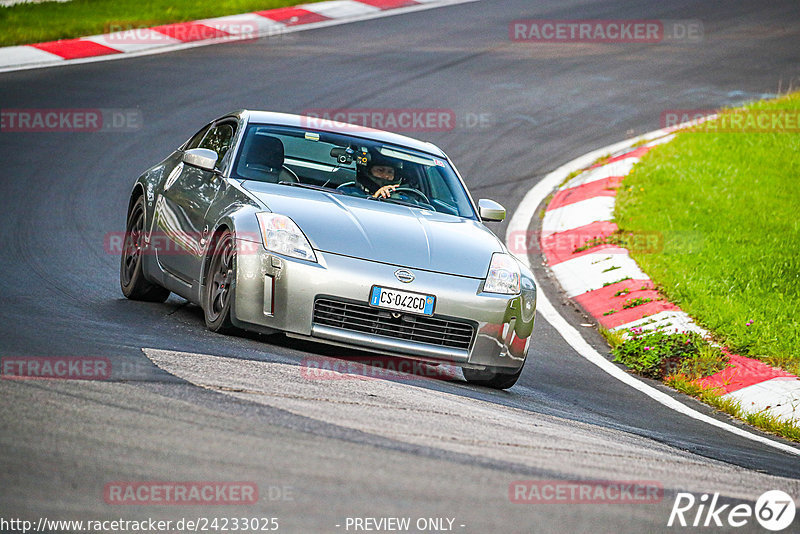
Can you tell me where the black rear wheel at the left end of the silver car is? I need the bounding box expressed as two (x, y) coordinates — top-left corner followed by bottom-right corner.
(119, 196), (169, 302)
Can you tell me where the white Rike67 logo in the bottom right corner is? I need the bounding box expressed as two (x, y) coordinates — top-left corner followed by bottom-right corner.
(667, 490), (796, 532)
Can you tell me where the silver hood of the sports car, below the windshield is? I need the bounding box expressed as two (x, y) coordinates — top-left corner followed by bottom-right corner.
(242, 181), (504, 278)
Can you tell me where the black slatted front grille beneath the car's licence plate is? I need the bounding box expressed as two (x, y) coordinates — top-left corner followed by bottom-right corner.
(314, 298), (475, 350)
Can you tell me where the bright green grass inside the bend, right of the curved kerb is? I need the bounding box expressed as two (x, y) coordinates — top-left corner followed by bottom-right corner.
(615, 93), (800, 374)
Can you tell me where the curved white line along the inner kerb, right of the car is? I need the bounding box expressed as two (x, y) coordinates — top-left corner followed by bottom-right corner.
(506, 130), (800, 456)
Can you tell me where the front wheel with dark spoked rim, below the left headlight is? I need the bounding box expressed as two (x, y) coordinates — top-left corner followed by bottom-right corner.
(203, 229), (236, 334)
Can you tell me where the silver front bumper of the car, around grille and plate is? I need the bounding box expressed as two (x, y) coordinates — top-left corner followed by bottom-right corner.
(232, 242), (536, 370)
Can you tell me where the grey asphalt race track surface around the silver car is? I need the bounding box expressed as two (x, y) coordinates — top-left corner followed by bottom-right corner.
(0, 0), (800, 532)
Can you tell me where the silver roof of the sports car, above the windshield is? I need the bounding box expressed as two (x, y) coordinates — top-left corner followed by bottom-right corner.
(226, 109), (447, 158)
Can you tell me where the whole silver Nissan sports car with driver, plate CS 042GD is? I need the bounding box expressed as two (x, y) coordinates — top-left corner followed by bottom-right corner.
(120, 111), (536, 389)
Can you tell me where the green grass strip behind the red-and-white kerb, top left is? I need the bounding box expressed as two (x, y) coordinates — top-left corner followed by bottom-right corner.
(0, 0), (319, 46)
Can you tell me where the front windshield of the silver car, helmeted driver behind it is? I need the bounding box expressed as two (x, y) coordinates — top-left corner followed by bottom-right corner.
(232, 124), (476, 219)
